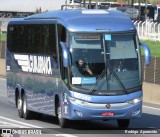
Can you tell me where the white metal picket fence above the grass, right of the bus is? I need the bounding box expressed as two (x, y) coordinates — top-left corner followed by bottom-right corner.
(133, 20), (160, 41)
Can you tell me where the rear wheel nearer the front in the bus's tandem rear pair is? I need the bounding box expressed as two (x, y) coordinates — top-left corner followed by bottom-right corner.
(22, 95), (32, 119)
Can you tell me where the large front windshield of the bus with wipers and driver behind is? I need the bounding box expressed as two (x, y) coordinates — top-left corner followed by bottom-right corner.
(69, 33), (141, 95)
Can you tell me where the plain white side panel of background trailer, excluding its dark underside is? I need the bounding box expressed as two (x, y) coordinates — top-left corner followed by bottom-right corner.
(0, 0), (65, 12)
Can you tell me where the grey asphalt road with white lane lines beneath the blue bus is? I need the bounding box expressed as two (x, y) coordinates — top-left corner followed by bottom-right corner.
(0, 78), (160, 137)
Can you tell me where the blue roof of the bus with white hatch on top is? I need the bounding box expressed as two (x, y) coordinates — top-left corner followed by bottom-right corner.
(10, 10), (136, 32)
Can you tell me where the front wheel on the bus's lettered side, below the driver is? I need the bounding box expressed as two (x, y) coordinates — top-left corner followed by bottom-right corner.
(56, 103), (68, 128)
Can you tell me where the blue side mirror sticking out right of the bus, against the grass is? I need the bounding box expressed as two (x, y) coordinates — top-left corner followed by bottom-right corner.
(140, 43), (151, 66)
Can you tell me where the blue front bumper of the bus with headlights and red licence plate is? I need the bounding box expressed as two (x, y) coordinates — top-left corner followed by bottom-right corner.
(62, 95), (142, 120)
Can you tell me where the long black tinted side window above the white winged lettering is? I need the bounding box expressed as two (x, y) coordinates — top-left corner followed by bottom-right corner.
(8, 24), (56, 56)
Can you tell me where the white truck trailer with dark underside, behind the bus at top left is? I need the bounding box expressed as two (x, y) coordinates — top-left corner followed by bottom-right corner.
(0, 0), (66, 18)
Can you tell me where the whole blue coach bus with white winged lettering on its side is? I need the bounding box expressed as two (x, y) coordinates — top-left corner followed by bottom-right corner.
(6, 10), (150, 128)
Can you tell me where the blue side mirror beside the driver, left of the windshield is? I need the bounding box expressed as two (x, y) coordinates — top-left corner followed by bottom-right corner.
(60, 42), (69, 67)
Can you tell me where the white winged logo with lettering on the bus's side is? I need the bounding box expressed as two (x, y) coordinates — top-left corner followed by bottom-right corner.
(14, 54), (52, 75)
